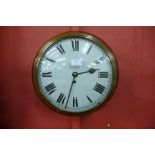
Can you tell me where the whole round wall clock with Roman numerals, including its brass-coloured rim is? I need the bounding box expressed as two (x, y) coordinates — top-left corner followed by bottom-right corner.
(33, 32), (117, 114)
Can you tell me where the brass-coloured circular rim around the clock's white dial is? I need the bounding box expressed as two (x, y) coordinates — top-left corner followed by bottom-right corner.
(32, 31), (119, 116)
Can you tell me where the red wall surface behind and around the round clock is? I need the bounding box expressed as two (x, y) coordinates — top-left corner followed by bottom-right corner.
(0, 27), (155, 128)
